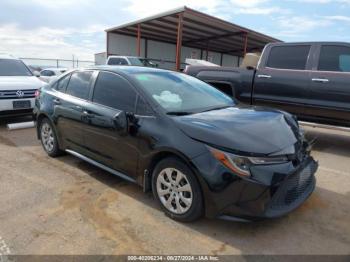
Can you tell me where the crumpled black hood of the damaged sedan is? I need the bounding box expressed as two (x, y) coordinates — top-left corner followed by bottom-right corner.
(173, 107), (299, 155)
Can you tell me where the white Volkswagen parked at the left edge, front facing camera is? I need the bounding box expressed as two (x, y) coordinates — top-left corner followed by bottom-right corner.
(0, 54), (45, 116)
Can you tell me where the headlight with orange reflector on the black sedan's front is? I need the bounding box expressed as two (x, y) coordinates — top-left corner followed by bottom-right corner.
(208, 147), (288, 177)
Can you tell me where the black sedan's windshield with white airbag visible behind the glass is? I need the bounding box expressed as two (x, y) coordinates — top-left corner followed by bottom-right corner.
(134, 71), (235, 115)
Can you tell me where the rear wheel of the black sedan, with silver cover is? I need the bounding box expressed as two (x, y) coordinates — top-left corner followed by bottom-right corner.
(40, 118), (62, 157)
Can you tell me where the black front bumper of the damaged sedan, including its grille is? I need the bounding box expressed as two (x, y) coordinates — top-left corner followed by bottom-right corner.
(191, 151), (318, 221)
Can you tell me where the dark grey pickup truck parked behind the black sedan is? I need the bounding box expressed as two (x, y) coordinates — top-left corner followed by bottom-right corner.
(185, 42), (350, 126)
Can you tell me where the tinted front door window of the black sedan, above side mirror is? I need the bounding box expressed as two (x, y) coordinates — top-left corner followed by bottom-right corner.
(93, 72), (136, 112)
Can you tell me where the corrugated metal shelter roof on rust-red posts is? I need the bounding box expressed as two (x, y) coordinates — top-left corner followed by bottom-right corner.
(106, 6), (281, 55)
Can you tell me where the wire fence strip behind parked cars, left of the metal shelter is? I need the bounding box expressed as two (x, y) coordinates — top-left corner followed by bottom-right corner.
(21, 58), (95, 68)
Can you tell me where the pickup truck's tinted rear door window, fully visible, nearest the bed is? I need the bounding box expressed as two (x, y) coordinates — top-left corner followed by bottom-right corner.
(266, 45), (311, 70)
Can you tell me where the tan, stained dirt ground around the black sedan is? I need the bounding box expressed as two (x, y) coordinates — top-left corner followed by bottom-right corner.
(0, 115), (350, 255)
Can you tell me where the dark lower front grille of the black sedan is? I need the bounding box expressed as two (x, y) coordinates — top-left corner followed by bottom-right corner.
(266, 161), (317, 216)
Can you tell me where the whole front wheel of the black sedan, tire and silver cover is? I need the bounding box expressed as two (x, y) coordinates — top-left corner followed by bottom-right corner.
(152, 158), (203, 222)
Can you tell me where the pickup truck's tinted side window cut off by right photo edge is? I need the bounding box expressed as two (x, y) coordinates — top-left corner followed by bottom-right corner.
(318, 45), (350, 72)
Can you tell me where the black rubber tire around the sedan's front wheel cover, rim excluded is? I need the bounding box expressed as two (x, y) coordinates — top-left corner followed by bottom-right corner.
(152, 157), (204, 222)
